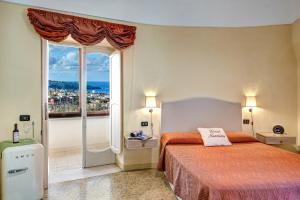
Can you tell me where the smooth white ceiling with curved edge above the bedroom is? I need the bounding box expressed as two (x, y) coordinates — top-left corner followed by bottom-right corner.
(4, 0), (300, 27)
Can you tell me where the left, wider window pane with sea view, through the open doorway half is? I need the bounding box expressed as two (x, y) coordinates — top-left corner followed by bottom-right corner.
(48, 44), (80, 113)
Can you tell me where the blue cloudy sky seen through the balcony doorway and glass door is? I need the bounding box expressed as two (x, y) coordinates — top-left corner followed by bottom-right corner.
(49, 44), (109, 81)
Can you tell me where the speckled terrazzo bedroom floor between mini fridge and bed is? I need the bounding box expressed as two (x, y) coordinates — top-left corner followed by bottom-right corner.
(44, 169), (176, 200)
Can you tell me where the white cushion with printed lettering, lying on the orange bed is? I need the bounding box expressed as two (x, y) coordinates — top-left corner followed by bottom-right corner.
(197, 128), (231, 146)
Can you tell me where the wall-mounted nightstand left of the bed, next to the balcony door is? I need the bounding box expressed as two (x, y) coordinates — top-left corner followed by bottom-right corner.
(124, 137), (158, 149)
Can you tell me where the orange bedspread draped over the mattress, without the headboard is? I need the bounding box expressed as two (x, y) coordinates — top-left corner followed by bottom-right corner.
(159, 133), (300, 200)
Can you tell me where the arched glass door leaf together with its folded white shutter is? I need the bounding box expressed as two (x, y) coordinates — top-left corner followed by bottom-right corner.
(81, 47), (121, 167)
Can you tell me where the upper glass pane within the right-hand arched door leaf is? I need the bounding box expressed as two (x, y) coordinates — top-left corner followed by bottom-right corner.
(86, 52), (109, 114)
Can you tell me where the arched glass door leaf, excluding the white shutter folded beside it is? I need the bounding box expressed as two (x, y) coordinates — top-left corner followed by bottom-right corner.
(82, 48), (115, 167)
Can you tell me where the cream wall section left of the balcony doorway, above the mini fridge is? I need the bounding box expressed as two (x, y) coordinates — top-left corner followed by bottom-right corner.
(0, 1), (41, 141)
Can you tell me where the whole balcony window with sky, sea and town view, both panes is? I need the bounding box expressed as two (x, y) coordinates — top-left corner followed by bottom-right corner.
(48, 44), (110, 118)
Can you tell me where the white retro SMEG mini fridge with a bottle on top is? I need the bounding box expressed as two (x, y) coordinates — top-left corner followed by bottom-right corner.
(1, 144), (44, 200)
